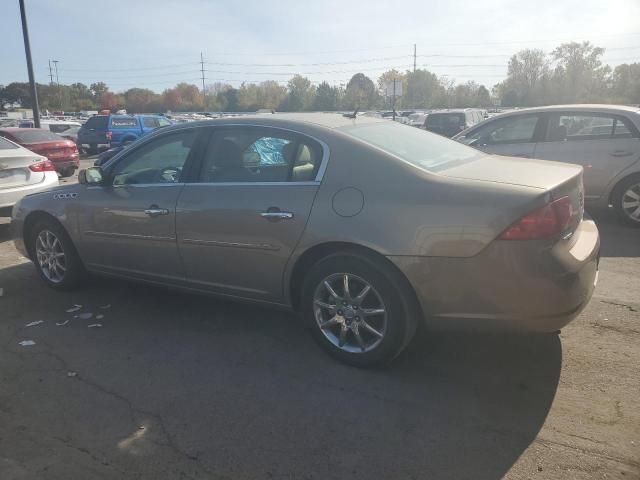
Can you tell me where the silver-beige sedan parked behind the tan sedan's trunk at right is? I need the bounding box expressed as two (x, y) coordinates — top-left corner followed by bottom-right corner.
(454, 105), (640, 227)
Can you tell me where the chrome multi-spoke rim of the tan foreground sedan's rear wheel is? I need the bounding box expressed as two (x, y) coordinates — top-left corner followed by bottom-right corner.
(313, 273), (387, 353)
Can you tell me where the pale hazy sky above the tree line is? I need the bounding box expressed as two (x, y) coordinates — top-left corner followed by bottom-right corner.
(0, 0), (640, 92)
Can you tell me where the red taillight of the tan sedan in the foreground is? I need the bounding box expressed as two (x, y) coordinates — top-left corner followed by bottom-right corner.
(500, 197), (573, 240)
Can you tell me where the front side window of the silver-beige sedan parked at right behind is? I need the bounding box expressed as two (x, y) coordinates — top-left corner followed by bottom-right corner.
(461, 115), (538, 146)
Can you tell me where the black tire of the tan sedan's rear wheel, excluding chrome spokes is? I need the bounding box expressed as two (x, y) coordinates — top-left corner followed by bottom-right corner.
(300, 251), (419, 367)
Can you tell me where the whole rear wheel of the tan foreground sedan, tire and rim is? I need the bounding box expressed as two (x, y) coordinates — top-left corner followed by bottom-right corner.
(301, 252), (416, 367)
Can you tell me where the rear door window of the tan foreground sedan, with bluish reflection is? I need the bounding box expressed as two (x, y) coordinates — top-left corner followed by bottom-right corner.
(200, 127), (322, 183)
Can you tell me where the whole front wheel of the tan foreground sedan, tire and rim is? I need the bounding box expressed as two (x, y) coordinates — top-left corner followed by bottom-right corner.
(30, 219), (85, 290)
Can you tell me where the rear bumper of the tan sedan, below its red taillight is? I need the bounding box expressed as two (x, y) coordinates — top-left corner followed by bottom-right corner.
(389, 220), (600, 332)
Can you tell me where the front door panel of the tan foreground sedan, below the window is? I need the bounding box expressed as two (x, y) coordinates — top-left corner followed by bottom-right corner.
(78, 184), (184, 279)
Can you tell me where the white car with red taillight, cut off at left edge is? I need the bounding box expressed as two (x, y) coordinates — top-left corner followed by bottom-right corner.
(0, 137), (58, 217)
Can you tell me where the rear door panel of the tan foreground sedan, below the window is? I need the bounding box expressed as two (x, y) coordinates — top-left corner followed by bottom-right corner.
(176, 183), (318, 302)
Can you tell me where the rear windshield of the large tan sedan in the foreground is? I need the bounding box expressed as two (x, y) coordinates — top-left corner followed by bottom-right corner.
(340, 122), (484, 171)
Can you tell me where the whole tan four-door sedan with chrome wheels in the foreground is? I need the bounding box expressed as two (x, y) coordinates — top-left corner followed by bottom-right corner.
(11, 114), (599, 365)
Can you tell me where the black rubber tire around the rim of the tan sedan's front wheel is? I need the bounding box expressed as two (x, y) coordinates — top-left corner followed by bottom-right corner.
(28, 219), (86, 290)
